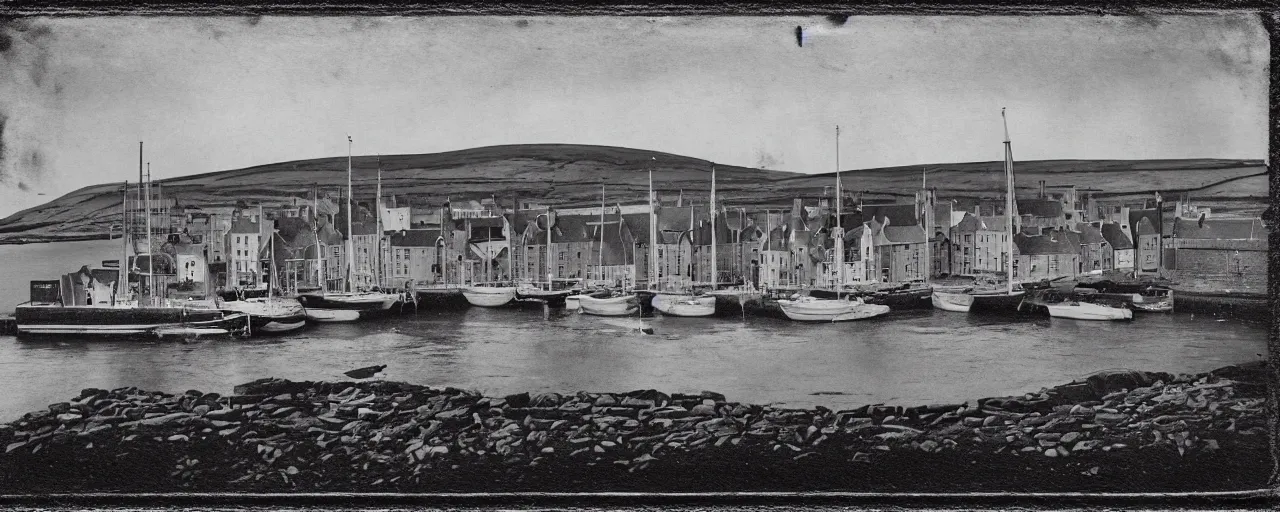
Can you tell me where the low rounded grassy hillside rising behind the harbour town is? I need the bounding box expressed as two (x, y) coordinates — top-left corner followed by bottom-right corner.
(0, 145), (1268, 243)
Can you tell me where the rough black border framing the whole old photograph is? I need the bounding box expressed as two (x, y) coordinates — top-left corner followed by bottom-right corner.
(0, 0), (1280, 508)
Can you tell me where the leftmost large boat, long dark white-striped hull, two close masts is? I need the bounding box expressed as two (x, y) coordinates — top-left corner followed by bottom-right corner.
(14, 142), (248, 337)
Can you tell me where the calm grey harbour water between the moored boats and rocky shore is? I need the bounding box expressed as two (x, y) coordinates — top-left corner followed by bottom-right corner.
(0, 242), (1266, 421)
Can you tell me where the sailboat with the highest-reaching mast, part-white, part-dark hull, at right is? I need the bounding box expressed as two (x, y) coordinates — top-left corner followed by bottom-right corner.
(931, 109), (1027, 312)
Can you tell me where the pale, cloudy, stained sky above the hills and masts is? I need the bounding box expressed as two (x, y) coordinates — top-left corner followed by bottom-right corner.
(0, 14), (1268, 216)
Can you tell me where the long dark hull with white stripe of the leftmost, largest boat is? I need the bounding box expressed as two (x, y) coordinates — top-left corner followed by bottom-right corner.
(14, 306), (248, 337)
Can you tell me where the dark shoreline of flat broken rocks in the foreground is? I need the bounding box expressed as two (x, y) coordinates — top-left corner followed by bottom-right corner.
(0, 364), (1271, 493)
